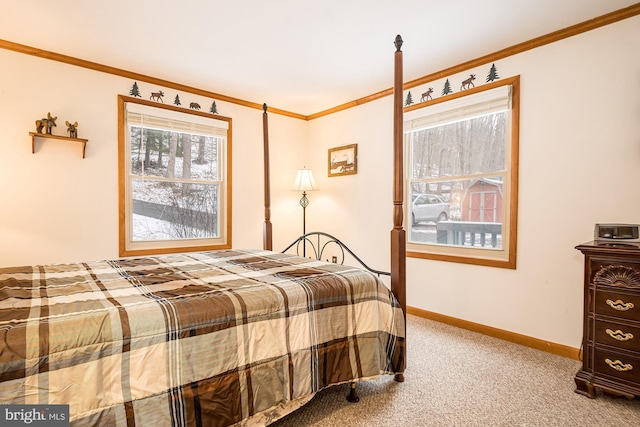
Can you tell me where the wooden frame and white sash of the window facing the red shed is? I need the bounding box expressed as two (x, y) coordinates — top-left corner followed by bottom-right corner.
(404, 76), (520, 269)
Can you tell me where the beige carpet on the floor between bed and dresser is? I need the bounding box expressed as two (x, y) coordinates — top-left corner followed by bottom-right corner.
(272, 316), (640, 427)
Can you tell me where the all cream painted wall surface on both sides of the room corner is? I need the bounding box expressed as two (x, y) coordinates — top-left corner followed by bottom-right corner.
(0, 17), (640, 348)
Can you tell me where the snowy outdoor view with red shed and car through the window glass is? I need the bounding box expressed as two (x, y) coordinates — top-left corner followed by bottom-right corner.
(408, 111), (508, 248)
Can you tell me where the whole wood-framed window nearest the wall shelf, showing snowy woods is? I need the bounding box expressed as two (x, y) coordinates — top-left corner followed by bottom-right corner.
(118, 96), (231, 256)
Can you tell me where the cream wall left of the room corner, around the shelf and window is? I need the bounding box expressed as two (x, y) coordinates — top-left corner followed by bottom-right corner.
(0, 50), (307, 266)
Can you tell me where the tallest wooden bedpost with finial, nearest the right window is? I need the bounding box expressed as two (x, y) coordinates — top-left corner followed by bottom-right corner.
(391, 34), (407, 382)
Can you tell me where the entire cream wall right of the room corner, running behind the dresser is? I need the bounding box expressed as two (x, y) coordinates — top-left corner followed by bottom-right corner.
(309, 17), (640, 348)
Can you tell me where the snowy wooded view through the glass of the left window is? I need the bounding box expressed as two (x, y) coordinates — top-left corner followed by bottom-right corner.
(130, 126), (220, 241)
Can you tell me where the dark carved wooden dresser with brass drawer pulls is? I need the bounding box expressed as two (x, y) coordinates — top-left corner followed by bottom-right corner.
(575, 242), (640, 398)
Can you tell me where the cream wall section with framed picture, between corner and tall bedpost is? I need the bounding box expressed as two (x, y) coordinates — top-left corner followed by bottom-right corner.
(307, 98), (393, 271)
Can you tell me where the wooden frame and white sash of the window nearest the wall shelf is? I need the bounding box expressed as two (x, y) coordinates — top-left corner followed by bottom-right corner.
(118, 95), (231, 256)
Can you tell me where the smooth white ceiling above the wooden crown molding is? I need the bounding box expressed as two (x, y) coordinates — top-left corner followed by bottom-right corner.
(0, 0), (637, 115)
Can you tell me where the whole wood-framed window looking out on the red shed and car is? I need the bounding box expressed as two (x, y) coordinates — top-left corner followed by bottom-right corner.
(404, 77), (519, 268)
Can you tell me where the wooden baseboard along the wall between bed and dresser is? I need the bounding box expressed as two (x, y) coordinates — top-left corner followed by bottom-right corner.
(407, 306), (580, 360)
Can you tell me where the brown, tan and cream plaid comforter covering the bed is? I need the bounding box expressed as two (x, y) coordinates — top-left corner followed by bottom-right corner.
(0, 250), (404, 427)
